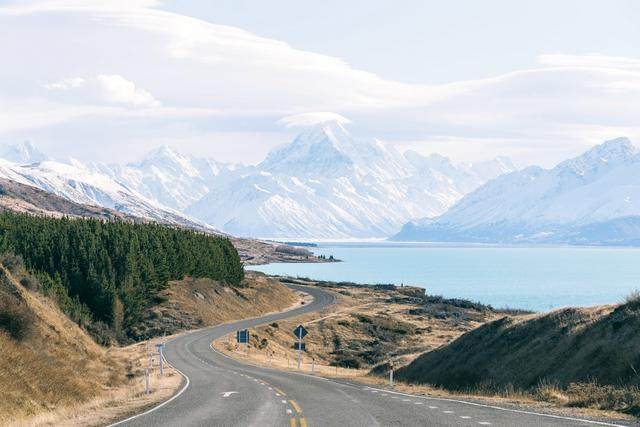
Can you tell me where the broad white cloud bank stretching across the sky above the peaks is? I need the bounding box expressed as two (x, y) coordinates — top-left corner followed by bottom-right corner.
(0, 0), (640, 166)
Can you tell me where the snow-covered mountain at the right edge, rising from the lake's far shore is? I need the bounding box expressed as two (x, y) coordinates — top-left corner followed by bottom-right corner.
(394, 138), (640, 244)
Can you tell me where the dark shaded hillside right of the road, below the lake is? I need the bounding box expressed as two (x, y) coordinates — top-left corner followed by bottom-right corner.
(397, 297), (640, 411)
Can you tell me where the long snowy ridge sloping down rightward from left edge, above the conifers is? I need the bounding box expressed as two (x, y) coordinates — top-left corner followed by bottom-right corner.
(0, 154), (211, 229)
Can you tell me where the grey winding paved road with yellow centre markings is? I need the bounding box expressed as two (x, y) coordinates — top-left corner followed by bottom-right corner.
(114, 286), (623, 427)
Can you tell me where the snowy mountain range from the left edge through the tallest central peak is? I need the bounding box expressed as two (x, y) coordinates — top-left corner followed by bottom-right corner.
(0, 120), (515, 239)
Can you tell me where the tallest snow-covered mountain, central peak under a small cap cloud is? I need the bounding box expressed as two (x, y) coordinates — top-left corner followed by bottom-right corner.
(186, 120), (514, 238)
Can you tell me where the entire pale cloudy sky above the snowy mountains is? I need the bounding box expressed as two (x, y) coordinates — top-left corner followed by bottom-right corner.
(0, 0), (640, 166)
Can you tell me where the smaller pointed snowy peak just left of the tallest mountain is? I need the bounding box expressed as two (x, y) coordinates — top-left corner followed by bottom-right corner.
(88, 146), (243, 211)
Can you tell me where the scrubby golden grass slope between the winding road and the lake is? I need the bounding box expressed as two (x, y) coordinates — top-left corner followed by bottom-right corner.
(221, 282), (497, 370)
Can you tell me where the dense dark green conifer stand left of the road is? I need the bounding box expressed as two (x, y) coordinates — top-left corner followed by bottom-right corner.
(0, 211), (244, 342)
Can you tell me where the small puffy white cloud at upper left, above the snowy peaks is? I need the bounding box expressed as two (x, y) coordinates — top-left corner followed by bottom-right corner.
(44, 74), (160, 108)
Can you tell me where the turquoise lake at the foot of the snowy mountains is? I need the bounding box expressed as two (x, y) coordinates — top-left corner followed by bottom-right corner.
(247, 243), (640, 311)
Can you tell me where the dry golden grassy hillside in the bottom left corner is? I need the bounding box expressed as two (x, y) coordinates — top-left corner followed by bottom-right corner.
(0, 266), (125, 424)
